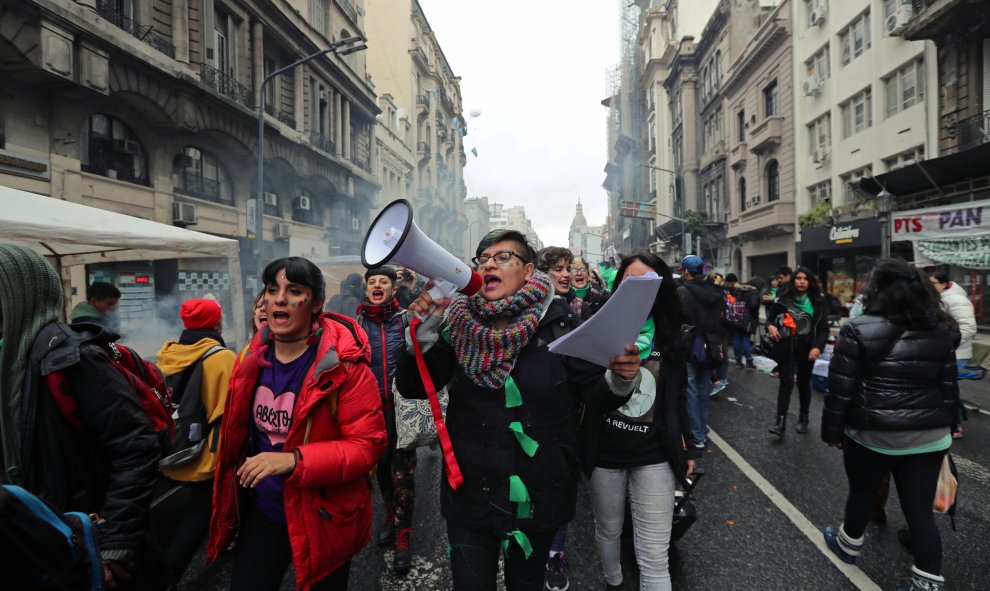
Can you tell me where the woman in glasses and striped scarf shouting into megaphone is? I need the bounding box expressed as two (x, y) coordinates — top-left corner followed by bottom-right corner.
(396, 229), (640, 591)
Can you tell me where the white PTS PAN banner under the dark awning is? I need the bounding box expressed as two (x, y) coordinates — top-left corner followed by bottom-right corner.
(892, 201), (990, 240)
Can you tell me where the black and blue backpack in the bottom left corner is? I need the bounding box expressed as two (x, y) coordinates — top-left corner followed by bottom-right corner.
(0, 484), (103, 591)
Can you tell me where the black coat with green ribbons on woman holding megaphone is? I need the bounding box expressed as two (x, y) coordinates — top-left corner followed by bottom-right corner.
(396, 297), (629, 536)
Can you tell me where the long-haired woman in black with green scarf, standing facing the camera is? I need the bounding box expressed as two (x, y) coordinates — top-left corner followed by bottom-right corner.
(767, 267), (829, 438)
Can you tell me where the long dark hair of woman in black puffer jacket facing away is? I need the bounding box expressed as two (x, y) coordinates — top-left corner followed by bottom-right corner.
(863, 259), (959, 330)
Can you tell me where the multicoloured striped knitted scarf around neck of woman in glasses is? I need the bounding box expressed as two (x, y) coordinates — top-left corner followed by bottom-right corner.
(447, 271), (553, 390)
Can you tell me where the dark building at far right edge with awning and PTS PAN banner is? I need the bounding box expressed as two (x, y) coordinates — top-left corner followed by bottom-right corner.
(860, 0), (990, 328)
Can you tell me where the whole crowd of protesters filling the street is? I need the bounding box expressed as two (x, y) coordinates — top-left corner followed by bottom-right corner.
(0, 234), (972, 591)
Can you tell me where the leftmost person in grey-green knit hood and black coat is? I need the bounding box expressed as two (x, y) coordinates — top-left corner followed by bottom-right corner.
(0, 244), (160, 589)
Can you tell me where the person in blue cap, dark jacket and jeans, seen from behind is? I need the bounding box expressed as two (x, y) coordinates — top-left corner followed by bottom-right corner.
(677, 254), (725, 448)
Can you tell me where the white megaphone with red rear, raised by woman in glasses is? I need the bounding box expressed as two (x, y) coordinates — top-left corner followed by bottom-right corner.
(361, 199), (483, 308)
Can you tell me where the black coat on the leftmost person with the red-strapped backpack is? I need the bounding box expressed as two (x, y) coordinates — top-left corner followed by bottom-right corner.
(22, 322), (160, 550)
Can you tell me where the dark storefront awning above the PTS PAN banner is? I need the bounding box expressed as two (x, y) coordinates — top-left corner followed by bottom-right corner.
(859, 143), (990, 196)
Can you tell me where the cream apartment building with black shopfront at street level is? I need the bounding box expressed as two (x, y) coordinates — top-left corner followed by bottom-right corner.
(792, 0), (939, 302)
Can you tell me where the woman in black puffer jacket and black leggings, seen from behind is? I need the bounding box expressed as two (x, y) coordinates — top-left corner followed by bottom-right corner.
(820, 260), (960, 591)
